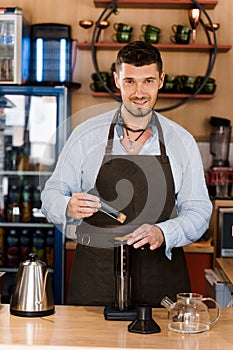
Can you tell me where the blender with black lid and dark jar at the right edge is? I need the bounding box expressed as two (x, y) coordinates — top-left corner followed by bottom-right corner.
(207, 117), (233, 199)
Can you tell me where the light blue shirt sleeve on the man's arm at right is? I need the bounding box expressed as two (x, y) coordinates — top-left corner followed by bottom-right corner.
(157, 129), (212, 259)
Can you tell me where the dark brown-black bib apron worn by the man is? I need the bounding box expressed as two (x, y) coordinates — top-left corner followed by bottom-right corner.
(68, 110), (190, 307)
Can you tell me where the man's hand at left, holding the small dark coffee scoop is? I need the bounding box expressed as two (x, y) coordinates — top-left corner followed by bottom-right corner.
(66, 193), (101, 220)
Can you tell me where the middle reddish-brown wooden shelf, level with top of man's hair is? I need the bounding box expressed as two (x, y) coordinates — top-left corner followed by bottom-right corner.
(77, 42), (232, 52)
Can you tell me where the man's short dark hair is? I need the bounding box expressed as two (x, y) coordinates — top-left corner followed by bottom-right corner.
(115, 41), (163, 75)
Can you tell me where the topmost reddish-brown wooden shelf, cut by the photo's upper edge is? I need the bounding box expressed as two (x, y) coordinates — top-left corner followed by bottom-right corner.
(94, 0), (218, 9)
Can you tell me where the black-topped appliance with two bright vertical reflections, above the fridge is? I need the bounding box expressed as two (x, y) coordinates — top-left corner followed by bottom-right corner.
(30, 23), (72, 84)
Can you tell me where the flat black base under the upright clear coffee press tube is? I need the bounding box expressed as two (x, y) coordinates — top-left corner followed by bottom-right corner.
(104, 305), (137, 321)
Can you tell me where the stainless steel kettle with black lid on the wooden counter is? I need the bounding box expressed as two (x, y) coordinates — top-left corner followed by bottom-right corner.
(10, 253), (55, 317)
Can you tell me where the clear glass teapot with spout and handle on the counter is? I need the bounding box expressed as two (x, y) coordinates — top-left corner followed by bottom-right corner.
(161, 293), (221, 334)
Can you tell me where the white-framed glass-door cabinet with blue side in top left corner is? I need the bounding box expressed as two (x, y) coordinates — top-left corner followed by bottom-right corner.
(0, 7), (30, 84)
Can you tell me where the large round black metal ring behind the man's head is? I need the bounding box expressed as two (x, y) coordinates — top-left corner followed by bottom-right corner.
(91, 0), (217, 112)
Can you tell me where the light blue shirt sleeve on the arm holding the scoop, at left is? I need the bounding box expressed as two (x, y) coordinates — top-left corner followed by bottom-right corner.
(41, 115), (112, 225)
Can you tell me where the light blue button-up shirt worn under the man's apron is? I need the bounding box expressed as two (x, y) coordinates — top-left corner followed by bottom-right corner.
(41, 110), (212, 259)
